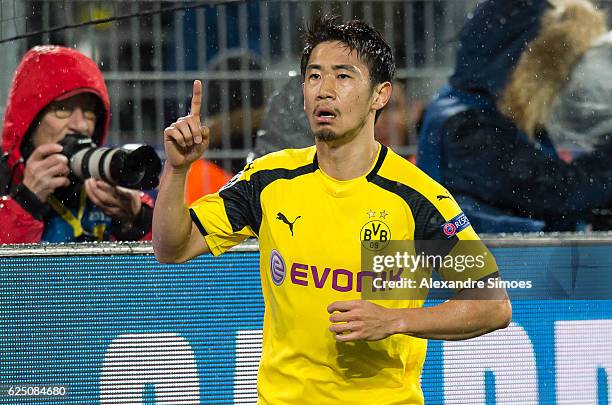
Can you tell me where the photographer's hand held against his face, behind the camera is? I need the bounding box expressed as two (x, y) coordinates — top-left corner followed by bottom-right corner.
(23, 143), (70, 202)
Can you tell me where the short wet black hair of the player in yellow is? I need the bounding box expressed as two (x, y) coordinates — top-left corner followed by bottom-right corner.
(301, 15), (395, 118)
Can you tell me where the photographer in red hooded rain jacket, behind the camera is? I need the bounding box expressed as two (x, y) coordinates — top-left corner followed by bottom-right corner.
(0, 46), (153, 243)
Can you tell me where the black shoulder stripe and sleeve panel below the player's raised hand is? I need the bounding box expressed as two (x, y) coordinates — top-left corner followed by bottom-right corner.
(219, 163), (316, 234)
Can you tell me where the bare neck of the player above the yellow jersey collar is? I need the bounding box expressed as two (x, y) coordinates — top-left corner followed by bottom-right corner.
(316, 130), (378, 180)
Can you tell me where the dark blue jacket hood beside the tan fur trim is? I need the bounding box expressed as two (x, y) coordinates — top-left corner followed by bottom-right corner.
(450, 0), (551, 98)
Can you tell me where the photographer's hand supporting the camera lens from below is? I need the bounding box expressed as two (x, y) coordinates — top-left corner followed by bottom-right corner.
(85, 178), (142, 226)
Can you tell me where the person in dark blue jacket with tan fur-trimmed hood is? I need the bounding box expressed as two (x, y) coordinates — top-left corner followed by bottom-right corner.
(418, 0), (612, 232)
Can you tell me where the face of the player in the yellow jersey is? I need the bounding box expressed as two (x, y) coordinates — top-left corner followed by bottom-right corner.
(304, 41), (376, 141)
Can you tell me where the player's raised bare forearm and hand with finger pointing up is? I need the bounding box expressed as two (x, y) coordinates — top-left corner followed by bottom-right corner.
(153, 80), (209, 263)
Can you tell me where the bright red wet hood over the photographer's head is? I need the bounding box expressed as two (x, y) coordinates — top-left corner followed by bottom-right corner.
(2, 45), (110, 178)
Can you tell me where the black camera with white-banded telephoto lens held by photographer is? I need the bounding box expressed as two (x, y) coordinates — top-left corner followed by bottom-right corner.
(60, 134), (161, 190)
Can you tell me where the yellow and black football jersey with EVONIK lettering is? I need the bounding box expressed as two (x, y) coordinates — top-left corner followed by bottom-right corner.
(190, 146), (497, 405)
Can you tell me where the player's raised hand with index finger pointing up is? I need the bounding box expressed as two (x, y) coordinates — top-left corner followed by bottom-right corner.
(164, 80), (210, 170)
